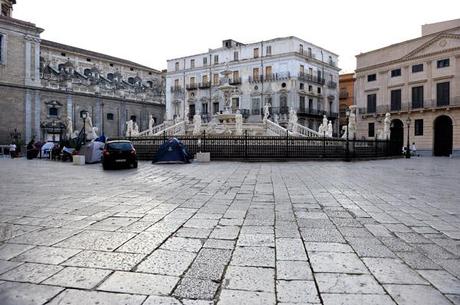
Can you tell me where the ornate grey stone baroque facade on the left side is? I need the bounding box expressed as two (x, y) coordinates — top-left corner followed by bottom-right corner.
(0, 0), (165, 144)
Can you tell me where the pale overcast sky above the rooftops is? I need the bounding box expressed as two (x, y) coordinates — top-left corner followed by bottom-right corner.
(13, 0), (460, 72)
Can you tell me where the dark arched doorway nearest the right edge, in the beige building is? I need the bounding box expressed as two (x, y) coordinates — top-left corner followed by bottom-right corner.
(433, 115), (452, 156)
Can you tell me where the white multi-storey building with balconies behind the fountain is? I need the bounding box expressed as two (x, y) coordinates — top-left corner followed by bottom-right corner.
(166, 36), (339, 132)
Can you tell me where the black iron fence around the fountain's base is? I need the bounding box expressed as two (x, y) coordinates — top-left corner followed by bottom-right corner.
(111, 133), (401, 161)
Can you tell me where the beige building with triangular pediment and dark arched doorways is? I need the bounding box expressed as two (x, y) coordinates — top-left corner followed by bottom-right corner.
(355, 19), (460, 156)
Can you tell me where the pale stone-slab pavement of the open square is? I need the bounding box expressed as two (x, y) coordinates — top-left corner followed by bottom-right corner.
(0, 158), (460, 305)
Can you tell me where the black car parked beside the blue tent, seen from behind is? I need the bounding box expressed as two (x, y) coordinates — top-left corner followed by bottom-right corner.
(101, 140), (137, 169)
